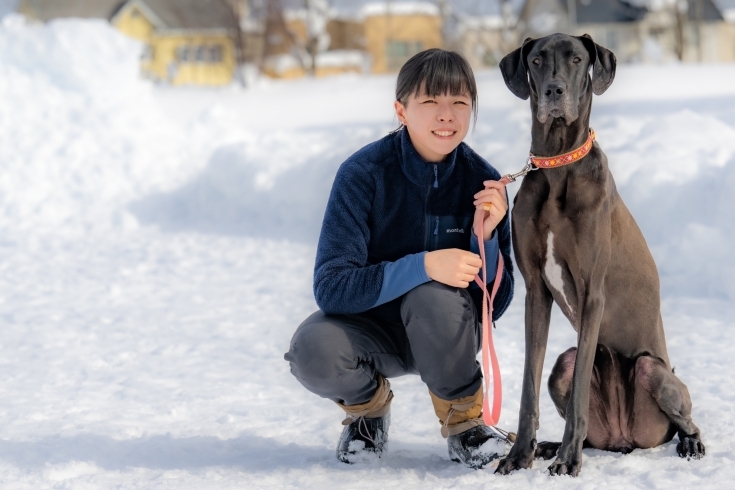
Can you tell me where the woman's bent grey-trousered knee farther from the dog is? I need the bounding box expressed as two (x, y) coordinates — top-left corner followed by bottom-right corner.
(284, 312), (375, 405)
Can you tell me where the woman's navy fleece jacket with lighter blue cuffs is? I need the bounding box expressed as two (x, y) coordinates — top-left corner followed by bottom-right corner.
(314, 128), (513, 321)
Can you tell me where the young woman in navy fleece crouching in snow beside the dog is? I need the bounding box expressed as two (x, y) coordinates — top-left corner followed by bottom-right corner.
(285, 49), (513, 468)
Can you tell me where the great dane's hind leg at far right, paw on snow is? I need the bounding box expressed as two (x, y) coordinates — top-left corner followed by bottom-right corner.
(635, 356), (705, 459)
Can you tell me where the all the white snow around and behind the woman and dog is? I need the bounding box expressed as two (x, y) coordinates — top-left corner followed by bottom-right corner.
(0, 16), (735, 489)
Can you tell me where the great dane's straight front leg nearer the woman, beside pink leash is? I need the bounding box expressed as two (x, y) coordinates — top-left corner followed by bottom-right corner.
(495, 277), (552, 475)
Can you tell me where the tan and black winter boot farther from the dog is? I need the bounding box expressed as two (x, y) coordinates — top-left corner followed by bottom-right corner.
(337, 375), (393, 464)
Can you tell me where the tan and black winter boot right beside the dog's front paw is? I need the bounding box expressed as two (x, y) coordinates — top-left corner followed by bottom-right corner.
(429, 386), (509, 469)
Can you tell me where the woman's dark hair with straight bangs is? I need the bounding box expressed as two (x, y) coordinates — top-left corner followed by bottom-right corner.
(396, 48), (477, 121)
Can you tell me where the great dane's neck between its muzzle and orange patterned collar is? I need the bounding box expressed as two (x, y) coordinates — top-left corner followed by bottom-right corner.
(531, 83), (592, 157)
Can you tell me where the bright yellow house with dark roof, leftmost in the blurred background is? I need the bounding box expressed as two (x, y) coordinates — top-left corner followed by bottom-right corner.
(18, 0), (237, 85)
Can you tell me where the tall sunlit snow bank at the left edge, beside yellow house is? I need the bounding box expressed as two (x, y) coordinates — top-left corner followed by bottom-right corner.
(0, 15), (198, 235)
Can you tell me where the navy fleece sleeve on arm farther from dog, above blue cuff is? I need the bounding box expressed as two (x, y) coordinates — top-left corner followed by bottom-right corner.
(314, 159), (385, 314)
